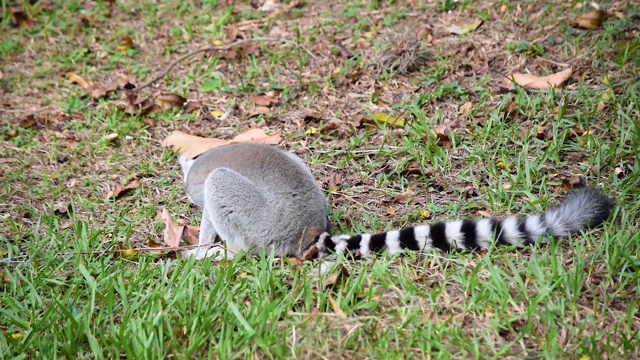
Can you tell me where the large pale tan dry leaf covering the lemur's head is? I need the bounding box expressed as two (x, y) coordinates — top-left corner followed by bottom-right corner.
(162, 129), (282, 159)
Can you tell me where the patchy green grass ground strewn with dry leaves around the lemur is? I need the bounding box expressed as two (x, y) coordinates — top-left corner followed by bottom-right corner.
(0, 0), (640, 359)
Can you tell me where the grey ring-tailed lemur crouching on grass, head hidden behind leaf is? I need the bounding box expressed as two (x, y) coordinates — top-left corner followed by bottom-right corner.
(179, 143), (613, 259)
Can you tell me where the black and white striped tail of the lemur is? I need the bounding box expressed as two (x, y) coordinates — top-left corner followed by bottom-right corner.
(316, 187), (613, 257)
